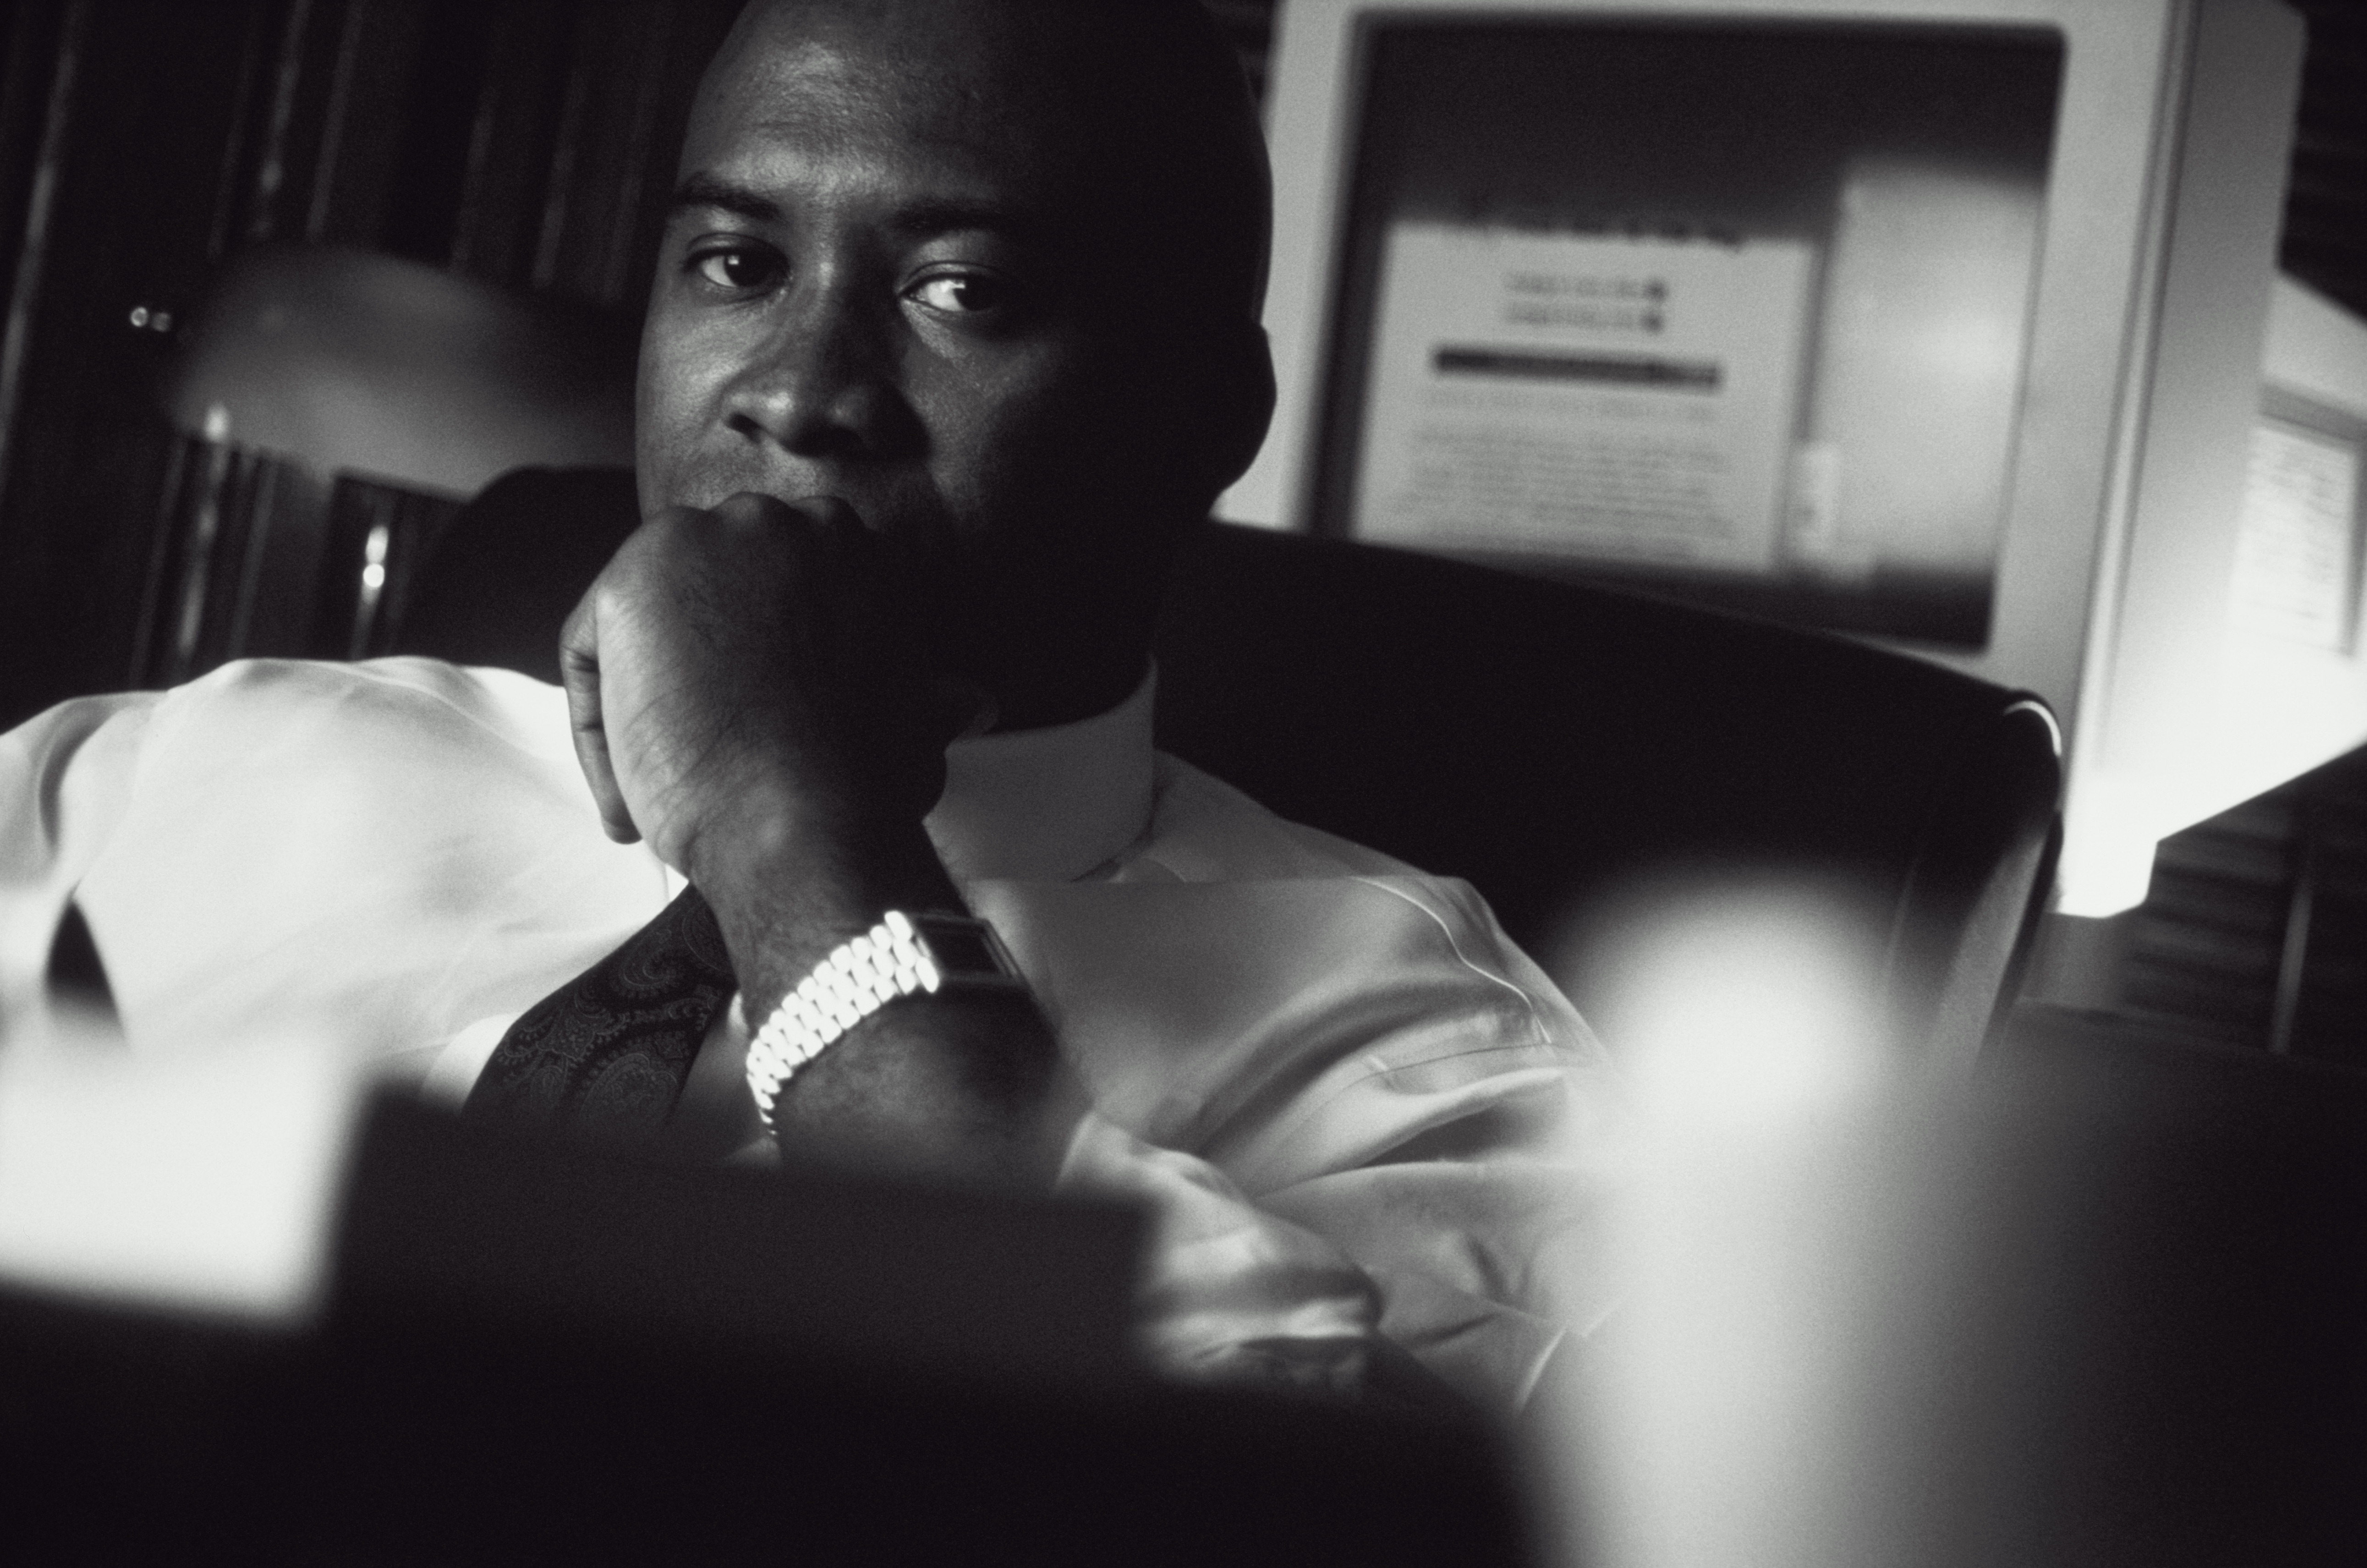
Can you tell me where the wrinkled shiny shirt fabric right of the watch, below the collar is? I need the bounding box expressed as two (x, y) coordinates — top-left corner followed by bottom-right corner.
(973, 763), (1624, 1412)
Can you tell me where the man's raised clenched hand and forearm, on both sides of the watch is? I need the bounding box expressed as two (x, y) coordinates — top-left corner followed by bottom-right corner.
(559, 495), (1084, 1184)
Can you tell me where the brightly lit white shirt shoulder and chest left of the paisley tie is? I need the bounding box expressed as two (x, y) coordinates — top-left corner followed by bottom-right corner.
(0, 659), (665, 1070)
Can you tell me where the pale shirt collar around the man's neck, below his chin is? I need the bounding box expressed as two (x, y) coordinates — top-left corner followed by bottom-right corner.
(928, 668), (1158, 881)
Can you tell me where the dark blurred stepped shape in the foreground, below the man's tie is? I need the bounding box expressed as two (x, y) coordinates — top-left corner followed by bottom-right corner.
(0, 1102), (1529, 1566)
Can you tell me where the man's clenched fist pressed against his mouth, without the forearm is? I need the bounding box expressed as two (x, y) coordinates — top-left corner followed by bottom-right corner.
(559, 495), (961, 881)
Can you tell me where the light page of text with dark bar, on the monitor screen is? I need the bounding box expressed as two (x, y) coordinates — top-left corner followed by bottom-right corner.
(1356, 222), (1815, 573)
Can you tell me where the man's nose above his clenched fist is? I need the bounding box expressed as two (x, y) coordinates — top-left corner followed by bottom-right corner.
(724, 279), (918, 460)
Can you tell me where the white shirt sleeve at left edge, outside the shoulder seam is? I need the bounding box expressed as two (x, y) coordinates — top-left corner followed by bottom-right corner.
(0, 692), (159, 1011)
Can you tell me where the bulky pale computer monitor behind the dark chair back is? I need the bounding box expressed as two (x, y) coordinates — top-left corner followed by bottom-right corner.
(1219, 0), (2300, 912)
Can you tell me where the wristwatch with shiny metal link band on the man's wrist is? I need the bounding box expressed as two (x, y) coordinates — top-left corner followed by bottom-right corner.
(748, 909), (1027, 1132)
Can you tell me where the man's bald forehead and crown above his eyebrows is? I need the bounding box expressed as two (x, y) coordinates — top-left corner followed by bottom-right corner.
(679, 0), (1266, 320)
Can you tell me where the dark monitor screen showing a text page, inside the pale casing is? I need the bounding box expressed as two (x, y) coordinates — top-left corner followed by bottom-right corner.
(1311, 12), (2064, 649)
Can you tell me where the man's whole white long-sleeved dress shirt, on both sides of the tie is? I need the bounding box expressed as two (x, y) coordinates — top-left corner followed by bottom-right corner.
(0, 659), (1617, 1409)
